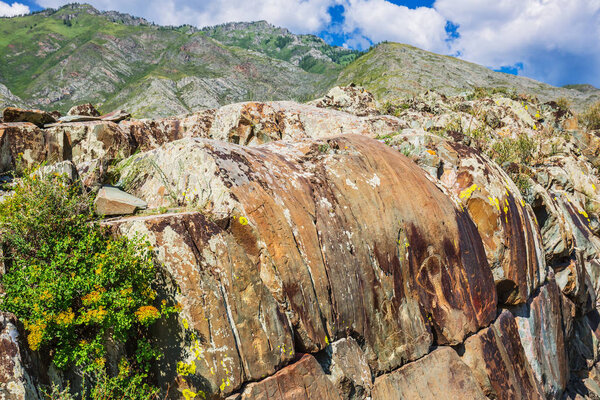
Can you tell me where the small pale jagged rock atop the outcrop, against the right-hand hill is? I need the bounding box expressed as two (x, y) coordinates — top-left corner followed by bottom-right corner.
(308, 85), (379, 117)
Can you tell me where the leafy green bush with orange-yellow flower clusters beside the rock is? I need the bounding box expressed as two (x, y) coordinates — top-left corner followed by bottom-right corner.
(0, 174), (176, 398)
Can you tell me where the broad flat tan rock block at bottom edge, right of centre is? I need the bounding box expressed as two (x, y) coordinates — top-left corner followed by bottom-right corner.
(373, 347), (488, 400)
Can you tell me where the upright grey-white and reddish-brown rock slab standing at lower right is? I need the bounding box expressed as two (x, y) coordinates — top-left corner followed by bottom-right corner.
(514, 280), (569, 399)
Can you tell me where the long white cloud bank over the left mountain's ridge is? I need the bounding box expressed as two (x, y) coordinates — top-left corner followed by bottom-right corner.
(37, 0), (339, 33)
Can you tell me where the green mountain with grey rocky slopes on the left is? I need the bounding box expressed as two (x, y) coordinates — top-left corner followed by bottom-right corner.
(0, 4), (357, 116)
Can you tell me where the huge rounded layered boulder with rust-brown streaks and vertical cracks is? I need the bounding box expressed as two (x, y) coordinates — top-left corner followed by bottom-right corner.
(113, 136), (496, 393)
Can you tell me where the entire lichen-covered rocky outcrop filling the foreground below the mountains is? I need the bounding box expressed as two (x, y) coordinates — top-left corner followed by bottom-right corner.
(0, 88), (600, 400)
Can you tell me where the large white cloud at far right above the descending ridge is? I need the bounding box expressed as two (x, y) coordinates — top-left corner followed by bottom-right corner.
(434, 0), (600, 85)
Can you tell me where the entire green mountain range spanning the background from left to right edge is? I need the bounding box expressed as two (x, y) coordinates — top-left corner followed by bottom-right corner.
(0, 4), (600, 117)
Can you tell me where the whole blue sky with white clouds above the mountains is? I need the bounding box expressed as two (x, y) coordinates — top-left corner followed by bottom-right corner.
(0, 0), (600, 87)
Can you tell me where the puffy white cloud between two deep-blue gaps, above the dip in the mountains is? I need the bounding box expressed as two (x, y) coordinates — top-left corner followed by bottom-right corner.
(342, 0), (447, 52)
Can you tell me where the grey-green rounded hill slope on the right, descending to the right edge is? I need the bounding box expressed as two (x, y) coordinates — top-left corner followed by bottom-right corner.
(337, 43), (600, 109)
